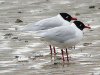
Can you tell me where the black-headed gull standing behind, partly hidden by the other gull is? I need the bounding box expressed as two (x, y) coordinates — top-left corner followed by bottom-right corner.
(22, 13), (77, 55)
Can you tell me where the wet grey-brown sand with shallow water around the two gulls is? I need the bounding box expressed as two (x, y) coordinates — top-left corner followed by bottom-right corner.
(0, 0), (100, 75)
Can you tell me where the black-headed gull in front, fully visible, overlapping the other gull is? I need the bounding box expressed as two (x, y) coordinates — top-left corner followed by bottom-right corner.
(37, 21), (90, 61)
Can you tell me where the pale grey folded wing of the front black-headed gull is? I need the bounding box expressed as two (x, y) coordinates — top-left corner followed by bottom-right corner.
(39, 25), (76, 43)
